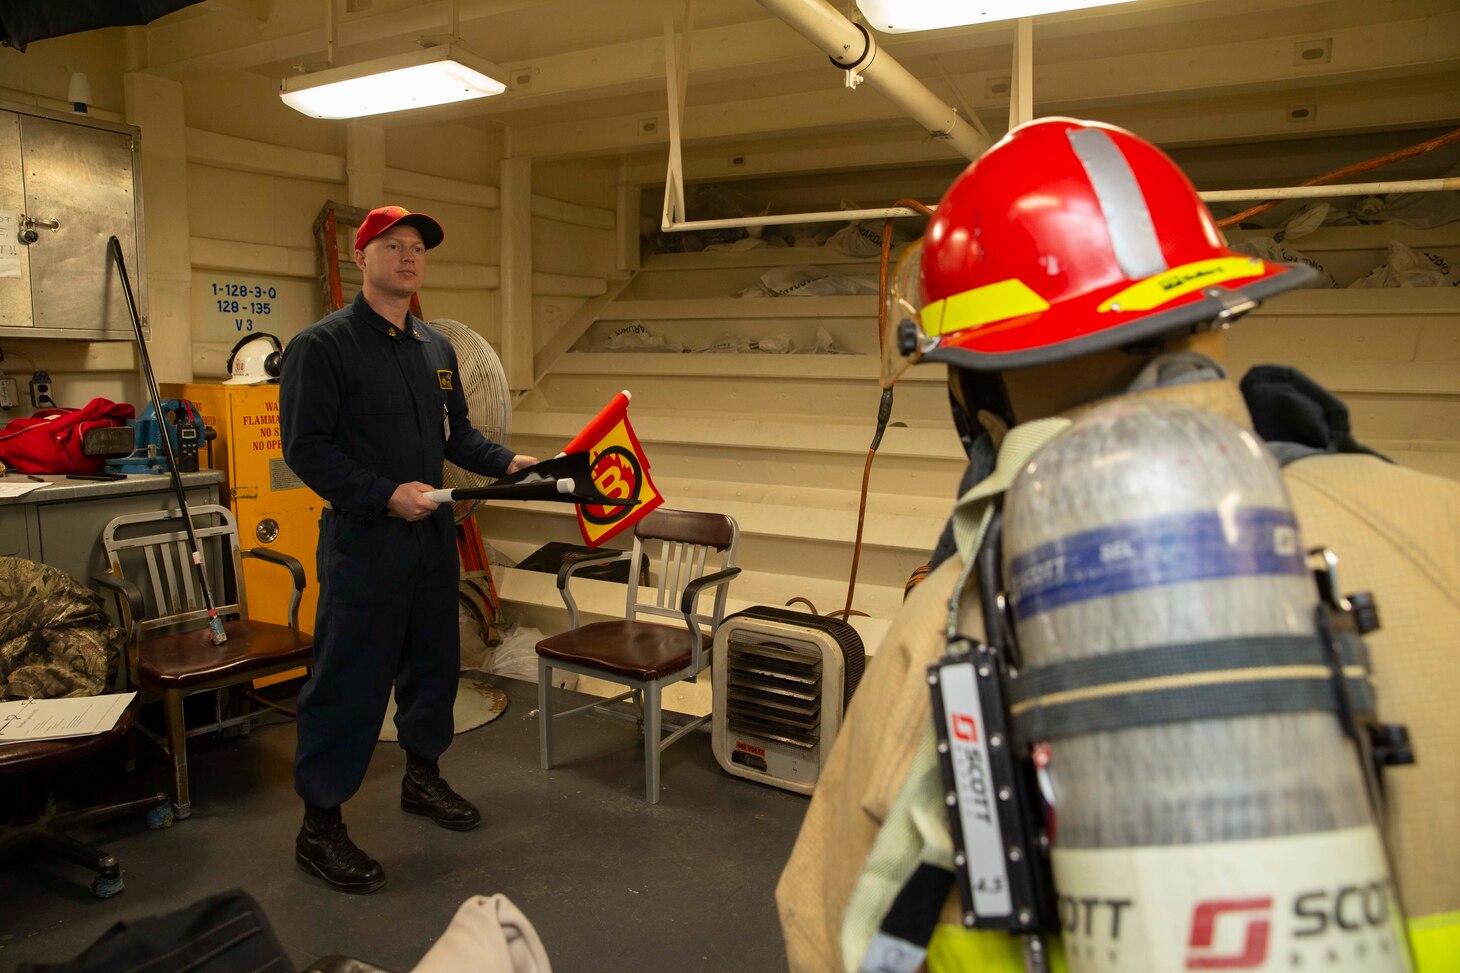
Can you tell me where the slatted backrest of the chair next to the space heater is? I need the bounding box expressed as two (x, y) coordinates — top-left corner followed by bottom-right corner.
(623, 507), (740, 672)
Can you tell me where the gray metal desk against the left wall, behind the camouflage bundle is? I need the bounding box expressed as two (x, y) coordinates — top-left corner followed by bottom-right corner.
(0, 469), (223, 586)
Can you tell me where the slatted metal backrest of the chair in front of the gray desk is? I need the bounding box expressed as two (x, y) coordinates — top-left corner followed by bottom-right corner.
(102, 504), (248, 634)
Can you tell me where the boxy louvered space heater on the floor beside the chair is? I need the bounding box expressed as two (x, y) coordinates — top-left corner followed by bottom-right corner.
(712, 606), (866, 793)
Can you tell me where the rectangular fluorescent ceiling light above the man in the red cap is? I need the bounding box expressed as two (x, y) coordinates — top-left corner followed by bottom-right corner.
(279, 44), (507, 118)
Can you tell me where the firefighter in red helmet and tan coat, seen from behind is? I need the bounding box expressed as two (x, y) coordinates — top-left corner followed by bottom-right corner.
(777, 118), (1460, 973)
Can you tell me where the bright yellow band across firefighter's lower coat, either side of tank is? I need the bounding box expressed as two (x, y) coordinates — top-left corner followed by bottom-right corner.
(927, 912), (1460, 973)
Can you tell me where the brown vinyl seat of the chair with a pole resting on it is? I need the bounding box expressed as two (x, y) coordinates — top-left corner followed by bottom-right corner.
(137, 618), (314, 691)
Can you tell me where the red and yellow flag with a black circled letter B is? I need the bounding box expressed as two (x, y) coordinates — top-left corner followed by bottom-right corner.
(562, 392), (664, 548)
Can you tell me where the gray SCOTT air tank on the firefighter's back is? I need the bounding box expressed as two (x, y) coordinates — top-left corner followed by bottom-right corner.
(1003, 402), (1407, 973)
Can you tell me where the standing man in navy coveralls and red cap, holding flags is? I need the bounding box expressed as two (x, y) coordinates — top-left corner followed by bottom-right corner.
(279, 206), (537, 893)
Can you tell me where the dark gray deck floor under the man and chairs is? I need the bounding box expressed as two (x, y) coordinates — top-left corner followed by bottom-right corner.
(0, 678), (806, 973)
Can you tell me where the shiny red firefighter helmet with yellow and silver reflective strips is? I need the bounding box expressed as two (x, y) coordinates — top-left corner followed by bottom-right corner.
(889, 118), (1313, 371)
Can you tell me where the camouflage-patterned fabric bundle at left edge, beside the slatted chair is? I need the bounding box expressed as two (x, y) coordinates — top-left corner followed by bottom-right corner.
(0, 557), (124, 700)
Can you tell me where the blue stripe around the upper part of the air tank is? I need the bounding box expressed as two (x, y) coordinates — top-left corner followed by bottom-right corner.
(1009, 507), (1307, 619)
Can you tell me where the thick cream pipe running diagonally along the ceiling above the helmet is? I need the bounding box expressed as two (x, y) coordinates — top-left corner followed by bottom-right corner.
(759, 0), (990, 159)
